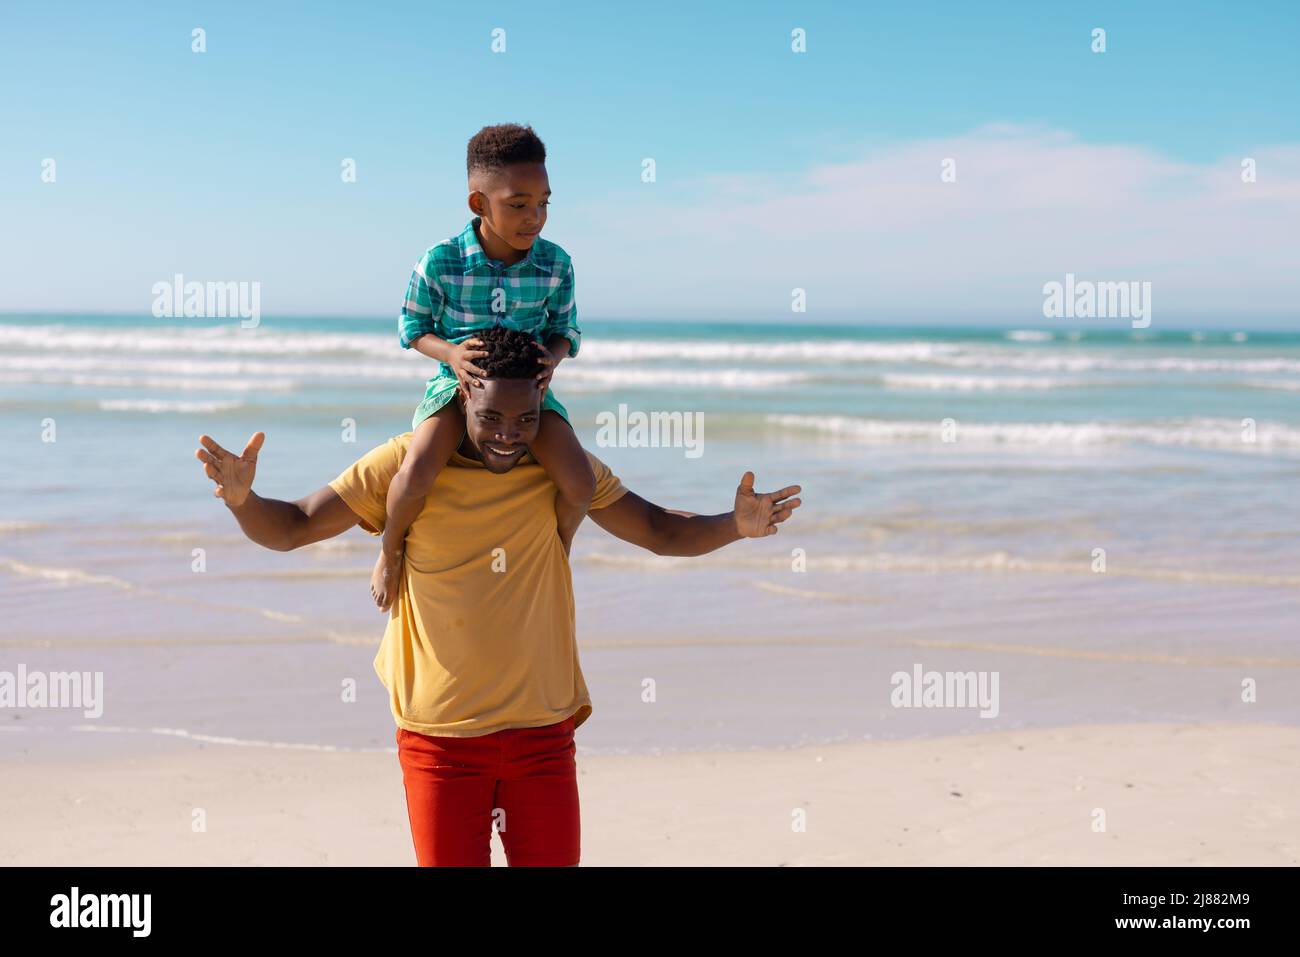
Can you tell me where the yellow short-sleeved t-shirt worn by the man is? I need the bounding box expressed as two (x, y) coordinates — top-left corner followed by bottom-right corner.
(329, 432), (627, 737)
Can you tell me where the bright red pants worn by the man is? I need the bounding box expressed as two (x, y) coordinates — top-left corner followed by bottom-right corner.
(398, 718), (580, 867)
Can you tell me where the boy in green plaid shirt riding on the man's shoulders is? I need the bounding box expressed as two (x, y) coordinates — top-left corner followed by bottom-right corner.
(371, 124), (595, 611)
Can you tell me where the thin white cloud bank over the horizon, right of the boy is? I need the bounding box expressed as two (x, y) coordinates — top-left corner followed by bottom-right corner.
(569, 124), (1300, 321)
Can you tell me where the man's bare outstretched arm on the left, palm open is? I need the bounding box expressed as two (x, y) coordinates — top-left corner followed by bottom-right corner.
(194, 432), (360, 551)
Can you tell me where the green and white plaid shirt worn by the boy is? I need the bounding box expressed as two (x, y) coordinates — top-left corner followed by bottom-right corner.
(398, 216), (582, 376)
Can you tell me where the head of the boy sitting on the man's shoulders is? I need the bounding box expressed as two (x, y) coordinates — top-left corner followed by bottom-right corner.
(465, 124), (551, 252)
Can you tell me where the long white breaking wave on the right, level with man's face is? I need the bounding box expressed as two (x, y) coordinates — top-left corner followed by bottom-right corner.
(766, 415), (1300, 452)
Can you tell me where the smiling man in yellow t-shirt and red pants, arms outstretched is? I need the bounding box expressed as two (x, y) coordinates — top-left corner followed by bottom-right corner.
(195, 328), (800, 866)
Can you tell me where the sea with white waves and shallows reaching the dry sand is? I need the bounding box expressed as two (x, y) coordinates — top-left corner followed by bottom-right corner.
(0, 313), (1300, 759)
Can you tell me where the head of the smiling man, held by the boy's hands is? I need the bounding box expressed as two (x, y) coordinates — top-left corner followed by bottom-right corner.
(458, 326), (542, 472)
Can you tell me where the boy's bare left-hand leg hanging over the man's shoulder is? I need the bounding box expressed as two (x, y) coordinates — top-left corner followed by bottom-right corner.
(371, 400), (465, 611)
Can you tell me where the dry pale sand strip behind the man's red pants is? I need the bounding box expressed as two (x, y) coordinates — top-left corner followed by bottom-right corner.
(0, 723), (1300, 866)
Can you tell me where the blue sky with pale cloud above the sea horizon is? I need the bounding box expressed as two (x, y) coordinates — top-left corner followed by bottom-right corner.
(0, 0), (1300, 326)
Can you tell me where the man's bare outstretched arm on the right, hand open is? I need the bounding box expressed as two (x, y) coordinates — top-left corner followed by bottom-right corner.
(589, 472), (802, 555)
